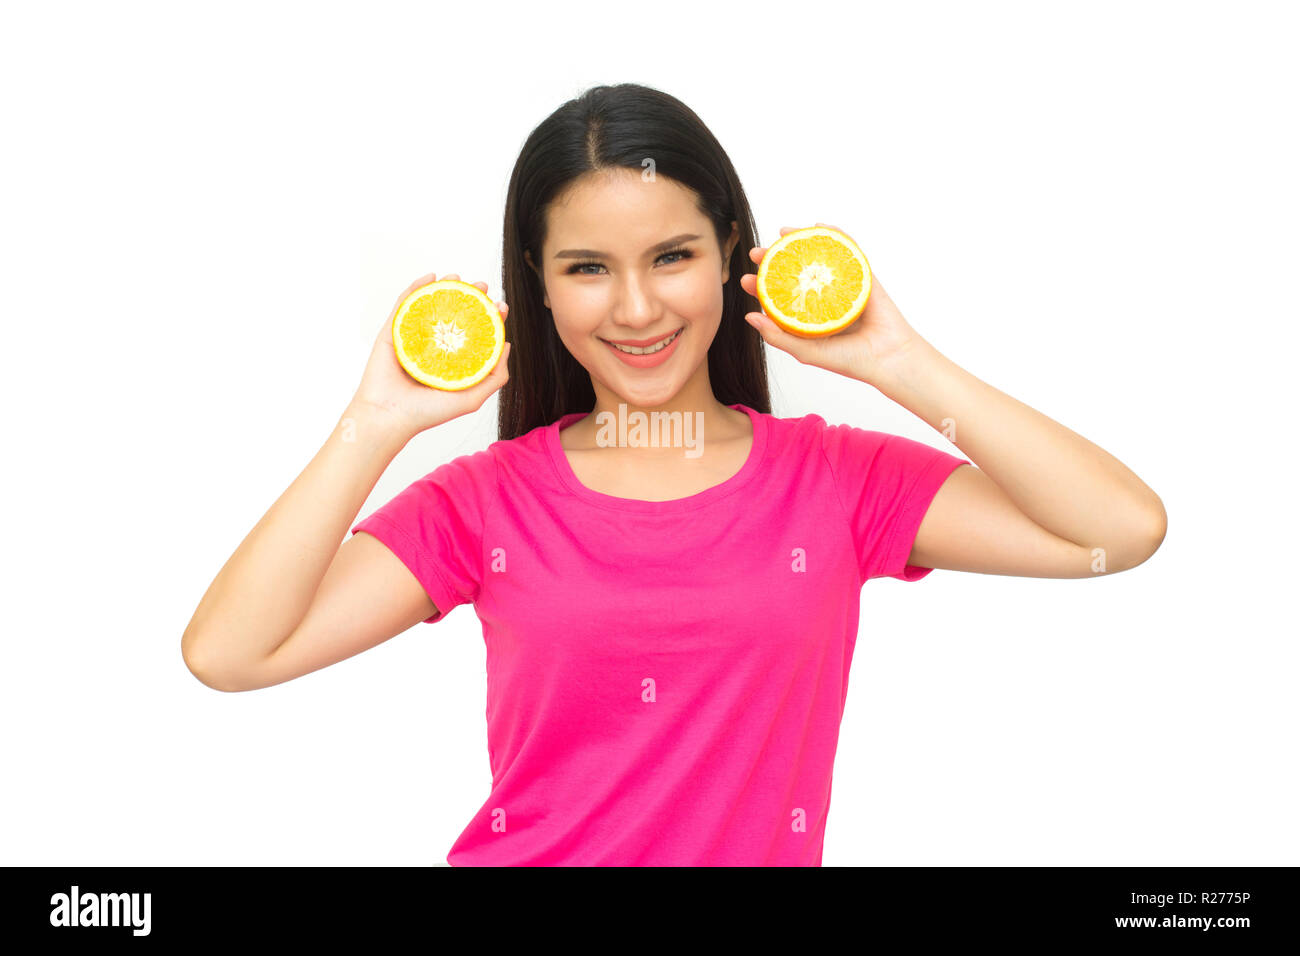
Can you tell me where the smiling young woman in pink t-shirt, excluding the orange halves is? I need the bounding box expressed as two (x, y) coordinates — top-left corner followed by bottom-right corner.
(182, 85), (1165, 865)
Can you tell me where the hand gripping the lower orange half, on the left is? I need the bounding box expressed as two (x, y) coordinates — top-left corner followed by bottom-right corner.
(352, 272), (510, 436)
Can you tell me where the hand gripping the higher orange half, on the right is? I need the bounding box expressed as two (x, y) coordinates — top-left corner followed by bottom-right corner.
(740, 222), (920, 385)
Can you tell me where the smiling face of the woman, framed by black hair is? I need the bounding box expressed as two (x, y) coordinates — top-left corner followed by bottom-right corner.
(534, 169), (740, 408)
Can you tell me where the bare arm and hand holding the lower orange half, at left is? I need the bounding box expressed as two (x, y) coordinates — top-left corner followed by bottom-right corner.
(181, 273), (510, 691)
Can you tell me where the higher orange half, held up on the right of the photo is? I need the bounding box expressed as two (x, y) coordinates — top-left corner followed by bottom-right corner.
(758, 226), (871, 338)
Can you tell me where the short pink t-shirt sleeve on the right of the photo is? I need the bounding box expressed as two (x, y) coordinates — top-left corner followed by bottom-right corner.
(822, 423), (970, 584)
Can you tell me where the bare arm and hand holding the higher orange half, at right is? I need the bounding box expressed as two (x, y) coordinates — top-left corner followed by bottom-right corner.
(741, 231), (1167, 578)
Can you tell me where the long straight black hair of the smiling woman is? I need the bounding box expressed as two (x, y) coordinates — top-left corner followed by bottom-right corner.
(497, 83), (772, 441)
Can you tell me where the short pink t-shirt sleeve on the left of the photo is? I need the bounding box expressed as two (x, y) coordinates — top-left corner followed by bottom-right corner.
(352, 451), (497, 624)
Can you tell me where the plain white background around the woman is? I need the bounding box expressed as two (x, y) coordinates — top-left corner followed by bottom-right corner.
(0, 0), (1300, 866)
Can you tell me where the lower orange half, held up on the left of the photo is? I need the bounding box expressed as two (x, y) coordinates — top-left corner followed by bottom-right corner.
(393, 278), (506, 392)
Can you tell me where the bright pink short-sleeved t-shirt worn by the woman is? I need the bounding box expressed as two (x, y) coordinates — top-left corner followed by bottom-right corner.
(352, 405), (969, 866)
